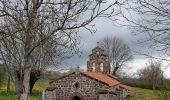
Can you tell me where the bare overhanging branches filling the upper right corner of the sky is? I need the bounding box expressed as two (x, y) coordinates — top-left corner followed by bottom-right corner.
(122, 0), (170, 61)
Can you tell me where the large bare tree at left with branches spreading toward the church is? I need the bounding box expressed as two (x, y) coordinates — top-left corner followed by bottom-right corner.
(0, 0), (119, 100)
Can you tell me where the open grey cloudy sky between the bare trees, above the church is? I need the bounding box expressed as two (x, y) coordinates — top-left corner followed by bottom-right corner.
(56, 16), (170, 78)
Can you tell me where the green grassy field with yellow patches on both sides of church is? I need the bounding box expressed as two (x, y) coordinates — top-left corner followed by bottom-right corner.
(0, 79), (170, 100)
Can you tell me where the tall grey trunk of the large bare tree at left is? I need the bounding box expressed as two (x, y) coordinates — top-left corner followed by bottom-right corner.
(20, 19), (35, 100)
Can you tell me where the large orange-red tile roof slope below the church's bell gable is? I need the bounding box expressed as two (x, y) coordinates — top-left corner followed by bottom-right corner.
(84, 72), (120, 86)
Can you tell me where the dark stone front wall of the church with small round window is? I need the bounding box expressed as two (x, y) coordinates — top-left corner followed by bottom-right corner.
(46, 72), (117, 100)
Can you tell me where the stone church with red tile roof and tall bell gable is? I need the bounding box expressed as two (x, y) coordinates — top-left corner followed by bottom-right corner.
(45, 46), (131, 100)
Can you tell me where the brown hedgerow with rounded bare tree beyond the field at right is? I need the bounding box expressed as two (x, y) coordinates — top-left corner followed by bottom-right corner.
(120, 60), (170, 90)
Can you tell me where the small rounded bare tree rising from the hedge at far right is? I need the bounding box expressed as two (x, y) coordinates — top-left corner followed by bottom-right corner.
(138, 61), (164, 89)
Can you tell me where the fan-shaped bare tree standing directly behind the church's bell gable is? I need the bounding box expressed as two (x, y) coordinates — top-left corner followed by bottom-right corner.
(100, 36), (133, 75)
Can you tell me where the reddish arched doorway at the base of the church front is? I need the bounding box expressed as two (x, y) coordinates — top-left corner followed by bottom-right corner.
(68, 92), (86, 100)
